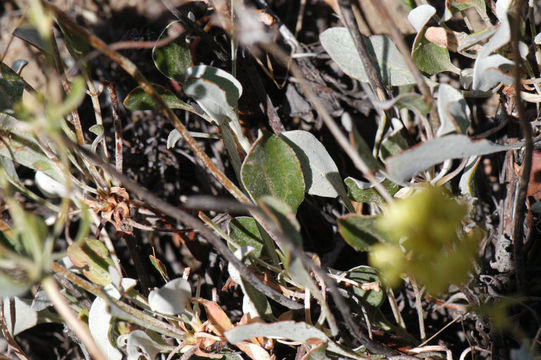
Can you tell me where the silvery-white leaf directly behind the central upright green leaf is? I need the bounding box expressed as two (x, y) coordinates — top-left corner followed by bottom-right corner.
(281, 130), (346, 198)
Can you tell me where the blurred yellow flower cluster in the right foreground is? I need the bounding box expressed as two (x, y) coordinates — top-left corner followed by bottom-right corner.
(369, 186), (483, 294)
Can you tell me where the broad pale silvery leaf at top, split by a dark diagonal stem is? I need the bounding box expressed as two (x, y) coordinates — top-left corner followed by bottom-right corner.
(319, 27), (415, 86)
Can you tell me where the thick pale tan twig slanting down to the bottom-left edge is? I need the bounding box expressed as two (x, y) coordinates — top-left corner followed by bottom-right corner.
(41, 277), (106, 360)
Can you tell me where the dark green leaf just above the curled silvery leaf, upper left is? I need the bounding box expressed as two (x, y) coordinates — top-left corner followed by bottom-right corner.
(152, 21), (192, 84)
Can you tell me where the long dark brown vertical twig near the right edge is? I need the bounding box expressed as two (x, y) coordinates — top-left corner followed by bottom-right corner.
(509, 0), (533, 291)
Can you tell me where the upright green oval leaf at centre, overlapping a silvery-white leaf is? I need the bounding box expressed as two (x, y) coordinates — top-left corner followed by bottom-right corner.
(241, 132), (304, 213)
